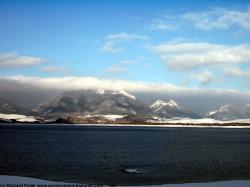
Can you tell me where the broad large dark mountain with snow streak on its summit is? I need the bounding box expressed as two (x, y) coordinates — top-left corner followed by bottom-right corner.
(33, 90), (152, 116)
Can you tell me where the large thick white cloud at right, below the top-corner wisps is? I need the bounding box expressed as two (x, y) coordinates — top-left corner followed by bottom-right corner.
(150, 42), (250, 70)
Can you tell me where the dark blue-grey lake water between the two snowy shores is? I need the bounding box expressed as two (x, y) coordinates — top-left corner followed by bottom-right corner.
(0, 125), (250, 185)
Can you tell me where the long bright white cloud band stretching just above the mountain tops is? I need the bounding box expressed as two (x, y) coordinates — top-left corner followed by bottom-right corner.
(0, 76), (246, 95)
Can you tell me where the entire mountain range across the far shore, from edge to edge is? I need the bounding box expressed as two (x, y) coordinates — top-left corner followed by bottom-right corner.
(0, 89), (250, 120)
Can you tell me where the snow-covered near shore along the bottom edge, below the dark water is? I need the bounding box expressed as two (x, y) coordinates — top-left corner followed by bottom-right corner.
(0, 175), (250, 187)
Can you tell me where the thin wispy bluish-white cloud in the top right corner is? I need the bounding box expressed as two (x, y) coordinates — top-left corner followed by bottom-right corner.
(182, 8), (250, 30)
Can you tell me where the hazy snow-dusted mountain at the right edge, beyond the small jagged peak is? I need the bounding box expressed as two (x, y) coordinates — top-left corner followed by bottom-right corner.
(207, 104), (250, 120)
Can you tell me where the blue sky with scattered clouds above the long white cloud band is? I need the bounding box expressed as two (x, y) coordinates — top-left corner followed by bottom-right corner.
(0, 0), (250, 92)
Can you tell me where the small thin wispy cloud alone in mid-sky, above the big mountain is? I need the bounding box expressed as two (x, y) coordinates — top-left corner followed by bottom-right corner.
(101, 32), (148, 53)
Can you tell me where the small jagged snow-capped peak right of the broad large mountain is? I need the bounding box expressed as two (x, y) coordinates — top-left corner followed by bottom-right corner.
(150, 100), (200, 118)
